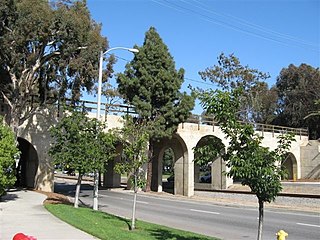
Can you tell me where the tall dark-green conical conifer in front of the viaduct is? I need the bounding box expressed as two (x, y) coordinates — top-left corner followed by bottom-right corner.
(117, 27), (194, 191)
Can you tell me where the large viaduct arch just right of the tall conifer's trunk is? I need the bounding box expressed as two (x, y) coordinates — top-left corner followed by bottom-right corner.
(151, 134), (189, 196)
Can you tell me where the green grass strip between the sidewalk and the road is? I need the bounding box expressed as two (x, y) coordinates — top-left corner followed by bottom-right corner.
(45, 204), (218, 240)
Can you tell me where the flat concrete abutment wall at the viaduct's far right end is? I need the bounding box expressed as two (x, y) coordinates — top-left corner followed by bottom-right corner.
(300, 140), (320, 179)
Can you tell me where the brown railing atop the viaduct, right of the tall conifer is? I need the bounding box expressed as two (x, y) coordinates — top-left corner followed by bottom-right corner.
(185, 115), (309, 137)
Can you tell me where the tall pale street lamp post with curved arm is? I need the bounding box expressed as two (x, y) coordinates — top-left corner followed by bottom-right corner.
(93, 47), (139, 210)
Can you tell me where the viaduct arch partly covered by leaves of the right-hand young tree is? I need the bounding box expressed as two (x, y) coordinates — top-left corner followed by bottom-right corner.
(194, 135), (227, 189)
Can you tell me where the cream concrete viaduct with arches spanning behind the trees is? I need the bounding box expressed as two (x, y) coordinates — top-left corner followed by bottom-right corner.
(0, 102), (320, 196)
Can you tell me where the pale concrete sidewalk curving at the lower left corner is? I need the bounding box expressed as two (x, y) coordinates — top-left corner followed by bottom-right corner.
(0, 190), (97, 240)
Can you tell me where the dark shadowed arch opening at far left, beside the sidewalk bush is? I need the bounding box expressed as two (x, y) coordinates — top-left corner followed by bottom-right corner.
(16, 137), (39, 188)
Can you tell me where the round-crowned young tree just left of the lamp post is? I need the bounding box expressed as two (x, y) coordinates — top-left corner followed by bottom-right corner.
(49, 109), (115, 207)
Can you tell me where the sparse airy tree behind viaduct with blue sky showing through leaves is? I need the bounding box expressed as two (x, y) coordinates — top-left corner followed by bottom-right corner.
(198, 53), (276, 122)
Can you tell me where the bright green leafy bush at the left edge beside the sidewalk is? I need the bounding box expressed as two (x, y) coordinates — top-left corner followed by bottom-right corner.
(0, 117), (20, 197)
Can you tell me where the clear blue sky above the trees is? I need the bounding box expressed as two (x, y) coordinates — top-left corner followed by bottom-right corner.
(87, 0), (320, 113)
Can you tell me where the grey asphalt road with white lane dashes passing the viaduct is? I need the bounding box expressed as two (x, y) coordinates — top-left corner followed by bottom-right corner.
(55, 183), (320, 240)
